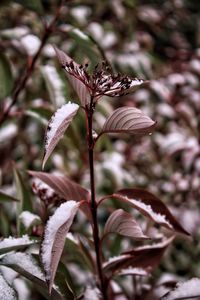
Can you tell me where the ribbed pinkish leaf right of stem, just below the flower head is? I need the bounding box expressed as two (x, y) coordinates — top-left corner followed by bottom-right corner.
(100, 106), (156, 135)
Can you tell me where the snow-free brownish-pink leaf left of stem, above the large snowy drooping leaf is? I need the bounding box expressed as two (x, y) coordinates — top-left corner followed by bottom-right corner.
(28, 171), (90, 201)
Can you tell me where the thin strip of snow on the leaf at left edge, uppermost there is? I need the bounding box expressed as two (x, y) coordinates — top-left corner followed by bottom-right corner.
(0, 235), (36, 254)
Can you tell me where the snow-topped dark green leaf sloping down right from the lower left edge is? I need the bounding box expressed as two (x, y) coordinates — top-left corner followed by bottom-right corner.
(0, 252), (65, 300)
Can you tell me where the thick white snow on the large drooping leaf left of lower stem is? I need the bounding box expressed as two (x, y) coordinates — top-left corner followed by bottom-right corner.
(42, 200), (79, 278)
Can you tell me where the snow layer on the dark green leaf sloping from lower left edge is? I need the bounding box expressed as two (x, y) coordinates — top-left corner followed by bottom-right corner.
(2, 252), (45, 280)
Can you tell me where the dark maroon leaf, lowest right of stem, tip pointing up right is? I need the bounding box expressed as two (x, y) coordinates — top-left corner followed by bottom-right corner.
(103, 237), (174, 276)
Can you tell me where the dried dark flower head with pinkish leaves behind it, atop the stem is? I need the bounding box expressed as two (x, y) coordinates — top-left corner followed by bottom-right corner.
(55, 47), (144, 106)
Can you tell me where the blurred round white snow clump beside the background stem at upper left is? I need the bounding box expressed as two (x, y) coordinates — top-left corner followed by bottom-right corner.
(21, 34), (41, 56)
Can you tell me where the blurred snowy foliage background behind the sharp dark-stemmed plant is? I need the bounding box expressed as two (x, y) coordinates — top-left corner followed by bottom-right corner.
(0, 0), (200, 298)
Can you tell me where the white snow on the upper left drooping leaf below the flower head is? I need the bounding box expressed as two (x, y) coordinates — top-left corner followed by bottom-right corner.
(46, 102), (79, 148)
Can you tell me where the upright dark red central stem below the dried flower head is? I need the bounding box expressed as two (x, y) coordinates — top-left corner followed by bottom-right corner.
(87, 98), (108, 300)
